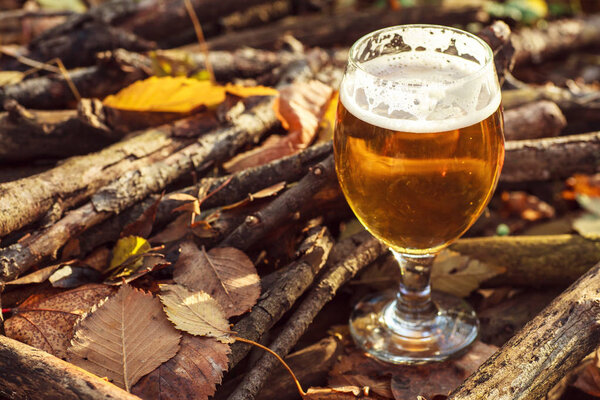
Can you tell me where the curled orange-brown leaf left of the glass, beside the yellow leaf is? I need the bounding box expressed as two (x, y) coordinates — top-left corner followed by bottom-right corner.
(224, 80), (333, 172)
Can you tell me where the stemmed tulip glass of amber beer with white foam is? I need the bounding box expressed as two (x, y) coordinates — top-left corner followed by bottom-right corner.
(334, 25), (504, 363)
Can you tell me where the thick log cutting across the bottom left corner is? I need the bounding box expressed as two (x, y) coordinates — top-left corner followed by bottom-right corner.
(0, 335), (139, 400)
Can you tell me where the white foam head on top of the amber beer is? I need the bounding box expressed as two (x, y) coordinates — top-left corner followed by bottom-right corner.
(340, 29), (500, 133)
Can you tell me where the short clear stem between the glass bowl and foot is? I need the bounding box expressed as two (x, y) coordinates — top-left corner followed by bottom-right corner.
(392, 250), (437, 325)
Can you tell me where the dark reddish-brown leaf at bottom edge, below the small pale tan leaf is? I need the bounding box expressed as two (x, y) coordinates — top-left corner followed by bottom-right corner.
(132, 333), (230, 400)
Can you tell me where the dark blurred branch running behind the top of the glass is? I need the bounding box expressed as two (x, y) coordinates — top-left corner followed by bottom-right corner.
(208, 7), (488, 50)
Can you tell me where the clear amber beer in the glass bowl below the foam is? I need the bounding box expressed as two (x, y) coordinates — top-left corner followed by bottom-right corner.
(334, 54), (504, 254)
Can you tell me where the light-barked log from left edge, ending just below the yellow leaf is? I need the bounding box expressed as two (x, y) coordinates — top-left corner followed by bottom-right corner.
(0, 113), (209, 237)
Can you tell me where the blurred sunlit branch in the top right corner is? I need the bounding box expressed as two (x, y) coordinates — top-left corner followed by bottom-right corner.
(512, 14), (600, 64)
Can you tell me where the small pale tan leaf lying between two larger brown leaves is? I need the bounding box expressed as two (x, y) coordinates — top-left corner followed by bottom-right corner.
(160, 285), (235, 343)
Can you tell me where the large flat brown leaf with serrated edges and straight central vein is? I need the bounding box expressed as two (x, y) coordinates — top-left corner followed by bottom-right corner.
(69, 285), (181, 391)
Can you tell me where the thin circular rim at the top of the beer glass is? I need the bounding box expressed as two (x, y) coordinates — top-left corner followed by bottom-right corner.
(348, 24), (495, 86)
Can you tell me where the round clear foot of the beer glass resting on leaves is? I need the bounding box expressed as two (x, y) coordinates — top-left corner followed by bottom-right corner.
(350, 292), (479, 364)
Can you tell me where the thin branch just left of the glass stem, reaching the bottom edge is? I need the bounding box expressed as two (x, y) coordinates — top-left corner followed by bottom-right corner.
(228, 233), (387, 400)
